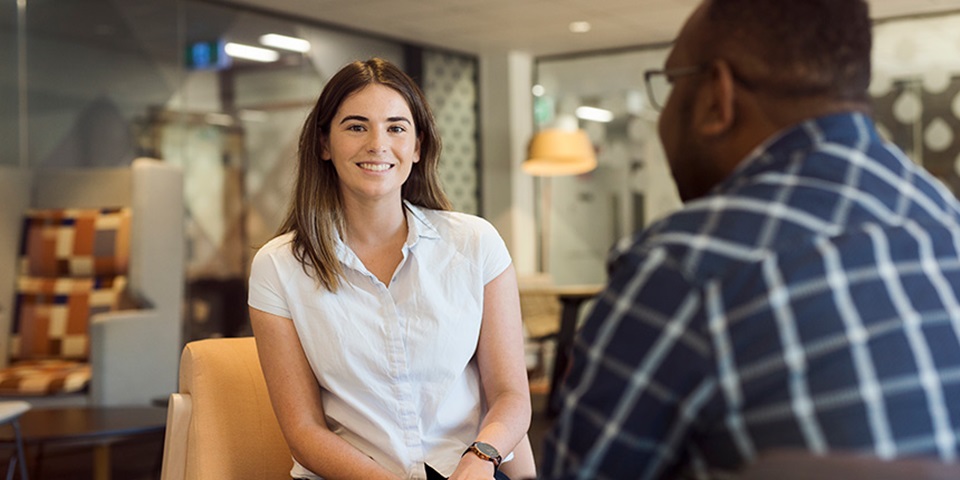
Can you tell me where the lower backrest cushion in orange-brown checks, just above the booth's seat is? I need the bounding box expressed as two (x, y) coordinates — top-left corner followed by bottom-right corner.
(10, 276), (126, 361)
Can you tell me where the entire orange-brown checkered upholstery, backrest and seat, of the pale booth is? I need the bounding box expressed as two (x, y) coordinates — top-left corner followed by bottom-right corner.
(0, 208), (130, 395)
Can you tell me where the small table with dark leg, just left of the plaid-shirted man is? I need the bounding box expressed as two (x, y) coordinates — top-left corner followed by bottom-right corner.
(524, 285), (603, 416)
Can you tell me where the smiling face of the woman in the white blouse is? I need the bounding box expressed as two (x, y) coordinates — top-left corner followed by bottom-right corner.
(323, 84), (420, 201)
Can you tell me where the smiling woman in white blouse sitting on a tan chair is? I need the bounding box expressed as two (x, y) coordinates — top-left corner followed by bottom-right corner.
(249, 58), (536, 479)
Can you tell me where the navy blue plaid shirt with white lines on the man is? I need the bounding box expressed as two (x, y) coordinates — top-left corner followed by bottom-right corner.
(540, 114), (960, 480)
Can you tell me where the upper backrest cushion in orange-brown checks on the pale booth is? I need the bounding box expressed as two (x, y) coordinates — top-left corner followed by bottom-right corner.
(19, 207), (130, 277)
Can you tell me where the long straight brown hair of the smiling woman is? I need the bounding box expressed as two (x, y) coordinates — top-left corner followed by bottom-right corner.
(278, 58), (451, 291)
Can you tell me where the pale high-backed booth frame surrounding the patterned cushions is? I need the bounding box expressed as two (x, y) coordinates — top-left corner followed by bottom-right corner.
(0, 159), (184, 406)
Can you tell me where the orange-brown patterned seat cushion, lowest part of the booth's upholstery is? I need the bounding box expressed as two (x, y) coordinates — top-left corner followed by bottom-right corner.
(0, 360), (90, 396)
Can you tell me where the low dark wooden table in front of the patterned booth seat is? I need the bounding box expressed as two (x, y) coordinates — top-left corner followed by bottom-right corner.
(0, 407), (167, 480)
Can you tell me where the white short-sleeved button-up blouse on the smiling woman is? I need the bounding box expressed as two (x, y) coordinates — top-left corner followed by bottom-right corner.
(249, 203), (511, 479)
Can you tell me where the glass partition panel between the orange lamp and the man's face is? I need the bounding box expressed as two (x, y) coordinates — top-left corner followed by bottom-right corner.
(534, 45), (680, 285)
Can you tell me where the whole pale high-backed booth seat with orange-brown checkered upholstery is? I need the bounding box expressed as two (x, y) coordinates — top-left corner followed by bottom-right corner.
(0, 158), (184, 406)
